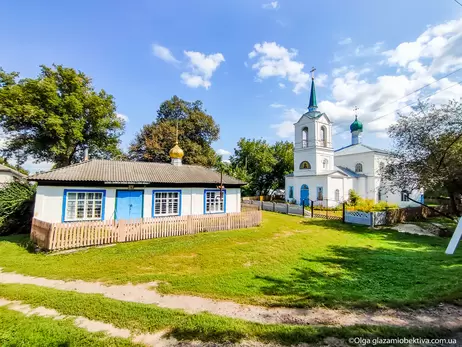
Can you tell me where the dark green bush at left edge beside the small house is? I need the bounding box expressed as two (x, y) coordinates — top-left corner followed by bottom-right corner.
(0, 182), (36, 235)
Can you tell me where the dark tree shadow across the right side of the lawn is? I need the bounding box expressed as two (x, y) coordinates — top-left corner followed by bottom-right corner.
(256, 242), (462, 307)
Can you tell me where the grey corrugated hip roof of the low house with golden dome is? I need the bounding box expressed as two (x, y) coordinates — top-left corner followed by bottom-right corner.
(29, 160), (246, 186)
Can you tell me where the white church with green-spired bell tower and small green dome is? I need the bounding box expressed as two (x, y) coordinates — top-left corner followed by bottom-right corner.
(285, 72), (423, 207)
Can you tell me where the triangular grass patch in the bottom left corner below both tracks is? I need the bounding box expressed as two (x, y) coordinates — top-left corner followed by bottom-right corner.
(0, 307), (140, 347)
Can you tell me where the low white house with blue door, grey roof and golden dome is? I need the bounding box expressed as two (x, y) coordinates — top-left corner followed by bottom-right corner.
(29, 144), (245, 222)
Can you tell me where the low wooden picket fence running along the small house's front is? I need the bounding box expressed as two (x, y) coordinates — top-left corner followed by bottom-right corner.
(31, 210), (262, 251)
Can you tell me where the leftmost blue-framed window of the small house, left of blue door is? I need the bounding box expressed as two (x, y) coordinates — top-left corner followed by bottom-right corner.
(63, 190), (105, 222)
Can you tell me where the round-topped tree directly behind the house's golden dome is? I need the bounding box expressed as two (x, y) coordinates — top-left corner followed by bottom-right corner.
(128, 96), (220, 167)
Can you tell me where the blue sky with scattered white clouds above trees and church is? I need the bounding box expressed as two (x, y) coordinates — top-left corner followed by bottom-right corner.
(0, 0), (462, 169)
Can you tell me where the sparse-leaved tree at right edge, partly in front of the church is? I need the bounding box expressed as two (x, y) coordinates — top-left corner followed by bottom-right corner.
(383, 100), (462, 215)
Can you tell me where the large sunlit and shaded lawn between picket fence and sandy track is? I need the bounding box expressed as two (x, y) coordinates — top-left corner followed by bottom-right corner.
(0, 212), (462, 306)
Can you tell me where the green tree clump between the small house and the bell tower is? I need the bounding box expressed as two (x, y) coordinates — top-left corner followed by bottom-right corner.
(230, 138), (294, 195)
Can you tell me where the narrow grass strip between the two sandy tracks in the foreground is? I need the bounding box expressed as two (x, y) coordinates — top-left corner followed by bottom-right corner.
(0, 284), (455, 346)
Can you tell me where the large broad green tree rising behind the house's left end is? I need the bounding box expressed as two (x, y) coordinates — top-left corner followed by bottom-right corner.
(0, 65), (124, 167)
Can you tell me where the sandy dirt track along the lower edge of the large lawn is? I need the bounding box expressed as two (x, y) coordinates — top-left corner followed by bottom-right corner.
(0, 269), (462, 328)
